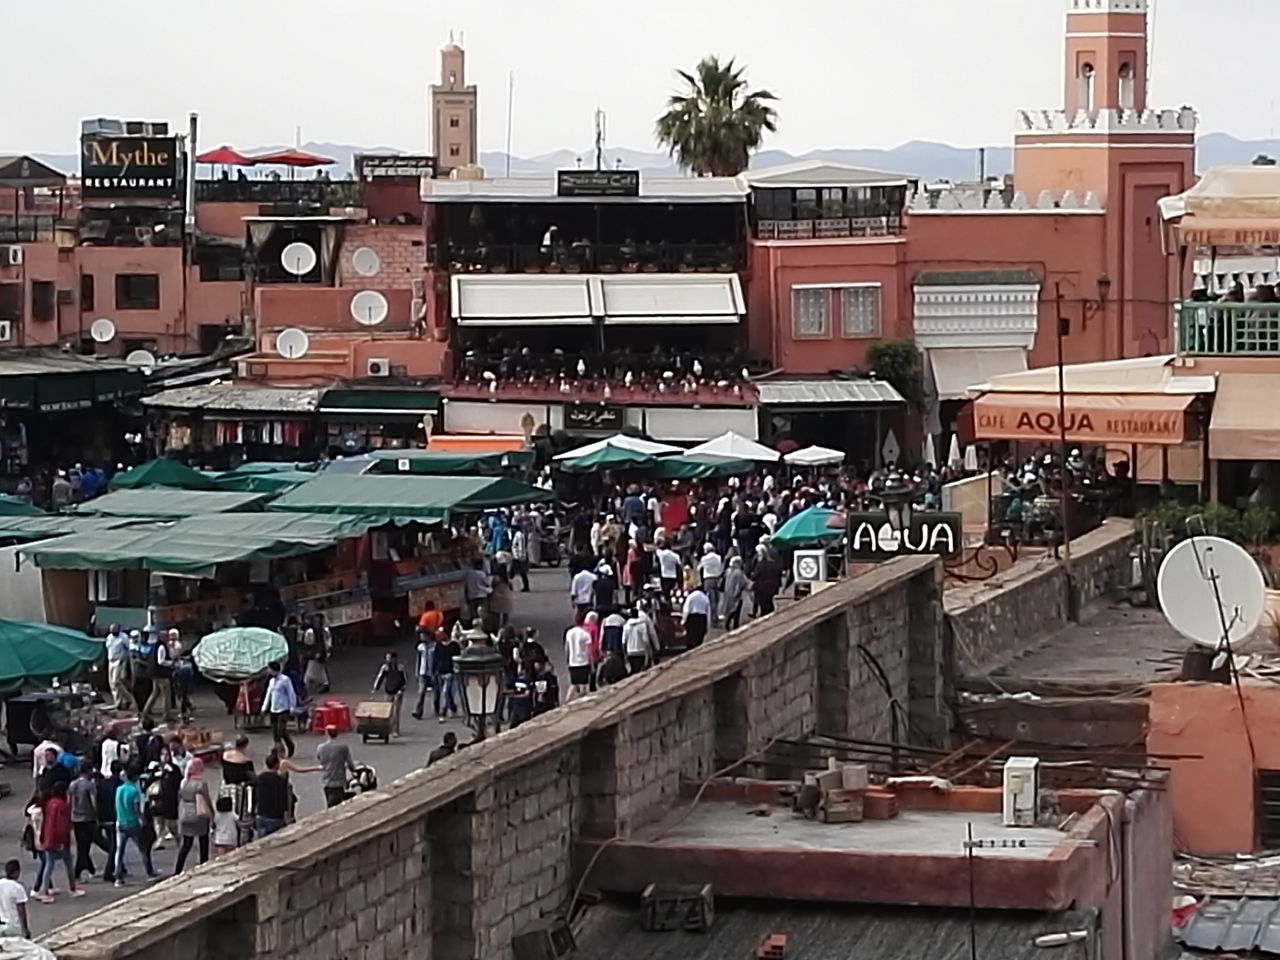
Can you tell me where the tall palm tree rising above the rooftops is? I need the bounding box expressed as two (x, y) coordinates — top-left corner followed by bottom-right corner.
(657, 56), (778, 177)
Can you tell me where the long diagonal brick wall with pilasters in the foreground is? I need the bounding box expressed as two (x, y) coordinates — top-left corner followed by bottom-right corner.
(45, 558), (945, 960)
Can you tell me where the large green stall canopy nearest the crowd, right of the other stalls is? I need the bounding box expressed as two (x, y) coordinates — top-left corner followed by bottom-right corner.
(271, 472), (552, 524)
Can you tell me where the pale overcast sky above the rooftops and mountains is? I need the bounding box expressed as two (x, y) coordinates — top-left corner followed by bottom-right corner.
(0, 0), (1280, 156)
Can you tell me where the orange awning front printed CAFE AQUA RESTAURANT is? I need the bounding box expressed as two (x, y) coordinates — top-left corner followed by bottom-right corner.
(973, 393), (1196, 443)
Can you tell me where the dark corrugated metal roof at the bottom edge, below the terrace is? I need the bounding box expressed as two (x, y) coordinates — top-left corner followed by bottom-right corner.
(575, 901), (1097, 960)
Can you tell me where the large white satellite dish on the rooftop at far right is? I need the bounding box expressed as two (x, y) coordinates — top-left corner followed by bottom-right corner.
(1156, 536), (1267, 649)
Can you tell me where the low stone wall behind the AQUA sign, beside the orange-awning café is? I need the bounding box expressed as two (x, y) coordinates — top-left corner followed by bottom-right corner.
(943, 520), (1134, 676)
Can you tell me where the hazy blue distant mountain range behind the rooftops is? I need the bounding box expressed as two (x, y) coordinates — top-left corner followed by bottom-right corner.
(36, 133), (1280, 180)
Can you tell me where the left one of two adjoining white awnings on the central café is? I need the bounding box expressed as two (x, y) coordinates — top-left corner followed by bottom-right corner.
(451, 274), (596, 326)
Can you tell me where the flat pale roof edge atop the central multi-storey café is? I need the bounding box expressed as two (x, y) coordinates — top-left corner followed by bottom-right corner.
(422, 174), (750, 204)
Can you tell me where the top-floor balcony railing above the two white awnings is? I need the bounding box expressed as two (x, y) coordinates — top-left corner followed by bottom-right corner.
(428, 243), (746, 274)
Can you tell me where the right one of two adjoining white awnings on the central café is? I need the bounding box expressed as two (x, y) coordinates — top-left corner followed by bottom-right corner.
(599, 274), (746, 325)
